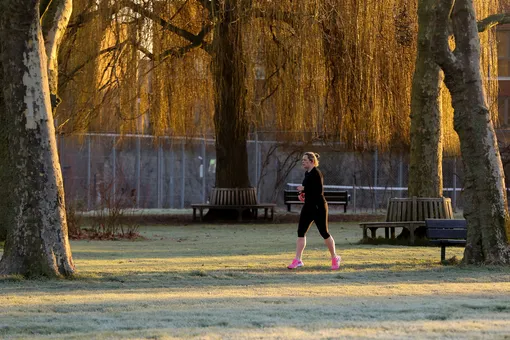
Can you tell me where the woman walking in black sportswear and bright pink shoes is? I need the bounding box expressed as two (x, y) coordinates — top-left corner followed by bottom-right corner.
(287, 152), (341, 270)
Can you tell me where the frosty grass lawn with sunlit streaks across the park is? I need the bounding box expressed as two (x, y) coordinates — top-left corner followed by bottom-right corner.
(0, 223), (510, 339)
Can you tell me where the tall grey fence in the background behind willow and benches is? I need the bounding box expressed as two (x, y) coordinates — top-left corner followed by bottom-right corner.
(58, 134), (462, 212)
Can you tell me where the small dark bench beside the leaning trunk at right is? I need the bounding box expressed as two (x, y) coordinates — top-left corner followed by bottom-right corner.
(425, 219), (467, 262)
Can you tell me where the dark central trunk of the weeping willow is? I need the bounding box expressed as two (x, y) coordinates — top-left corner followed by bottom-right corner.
(212, 0), (250, 188)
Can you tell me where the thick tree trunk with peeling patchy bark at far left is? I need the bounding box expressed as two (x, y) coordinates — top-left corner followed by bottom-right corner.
(0, 0), (75, 277)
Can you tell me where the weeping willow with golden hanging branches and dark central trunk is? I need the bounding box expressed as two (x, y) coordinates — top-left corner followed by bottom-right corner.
(55, 0), (502, 226)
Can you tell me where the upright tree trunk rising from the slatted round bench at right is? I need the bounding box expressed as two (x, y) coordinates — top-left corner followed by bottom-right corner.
(409, 0), (443, 197)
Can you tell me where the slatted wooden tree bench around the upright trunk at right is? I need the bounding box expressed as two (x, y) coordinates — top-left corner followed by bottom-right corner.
(360, 197), (453, 244)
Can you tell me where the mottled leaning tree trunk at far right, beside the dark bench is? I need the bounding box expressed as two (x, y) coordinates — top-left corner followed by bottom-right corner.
(434, 0), (510, 264)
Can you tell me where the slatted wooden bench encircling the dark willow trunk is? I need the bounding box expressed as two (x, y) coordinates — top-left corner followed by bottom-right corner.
(191, 188), (276, 221)
